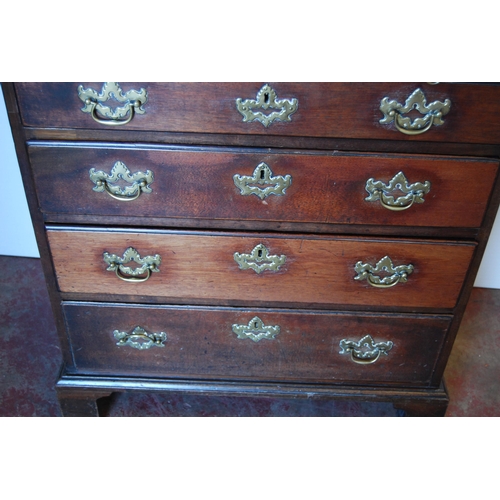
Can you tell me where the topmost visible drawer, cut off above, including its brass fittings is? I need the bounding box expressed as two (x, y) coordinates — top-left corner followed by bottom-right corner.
(16, 82), (500, 144)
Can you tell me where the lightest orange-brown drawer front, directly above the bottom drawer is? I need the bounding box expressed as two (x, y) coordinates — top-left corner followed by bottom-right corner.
(48, 228), (475, 309)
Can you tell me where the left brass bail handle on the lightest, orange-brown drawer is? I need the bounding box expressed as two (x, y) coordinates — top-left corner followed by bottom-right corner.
(103, 247), (161, 283)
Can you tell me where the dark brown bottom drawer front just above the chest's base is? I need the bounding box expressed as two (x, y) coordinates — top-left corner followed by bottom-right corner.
(63, 303), (450, 385)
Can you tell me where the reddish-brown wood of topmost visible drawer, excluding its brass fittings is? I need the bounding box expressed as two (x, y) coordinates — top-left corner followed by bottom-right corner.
(15, 82), (500, 144)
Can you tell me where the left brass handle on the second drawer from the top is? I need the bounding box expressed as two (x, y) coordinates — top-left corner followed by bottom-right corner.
(89, 161), (154, 201)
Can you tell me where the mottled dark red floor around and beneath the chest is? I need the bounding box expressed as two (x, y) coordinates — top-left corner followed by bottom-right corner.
(0, 256), (500, 417)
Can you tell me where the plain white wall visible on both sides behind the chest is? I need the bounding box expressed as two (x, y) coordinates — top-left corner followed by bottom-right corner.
(0, 87), (500, 288)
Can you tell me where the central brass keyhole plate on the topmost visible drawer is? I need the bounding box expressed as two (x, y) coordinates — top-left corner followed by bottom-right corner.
(236, 84), (299, 127)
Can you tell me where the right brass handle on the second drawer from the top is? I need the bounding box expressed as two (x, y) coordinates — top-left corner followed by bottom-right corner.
(365, 172), (431, 212)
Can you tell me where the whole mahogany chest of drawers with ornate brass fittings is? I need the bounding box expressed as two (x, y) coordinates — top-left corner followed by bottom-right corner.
(3, 82), (500, 416)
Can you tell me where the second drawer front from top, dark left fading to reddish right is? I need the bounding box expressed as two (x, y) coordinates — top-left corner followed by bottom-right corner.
(29, 144), (498, 227)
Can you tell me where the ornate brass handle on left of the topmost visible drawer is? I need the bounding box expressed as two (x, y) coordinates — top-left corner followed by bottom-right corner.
(78, 82), (148, 126)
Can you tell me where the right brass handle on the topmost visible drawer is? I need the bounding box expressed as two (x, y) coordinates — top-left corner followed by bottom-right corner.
(380, 89), (451, 135)
